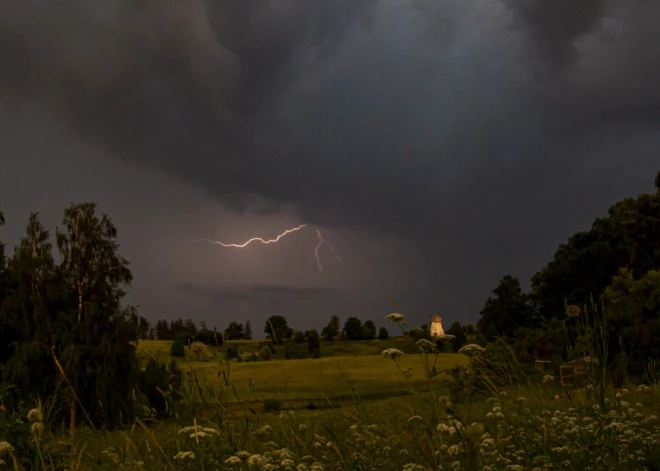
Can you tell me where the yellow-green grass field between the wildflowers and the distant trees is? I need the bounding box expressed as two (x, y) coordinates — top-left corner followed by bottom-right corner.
(138, 340), (467, 404)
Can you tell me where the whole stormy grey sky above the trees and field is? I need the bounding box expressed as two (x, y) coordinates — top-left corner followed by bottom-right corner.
(0, 0), (660, 336)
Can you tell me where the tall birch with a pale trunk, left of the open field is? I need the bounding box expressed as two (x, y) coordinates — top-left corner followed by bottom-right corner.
(55, 203), (138, 427)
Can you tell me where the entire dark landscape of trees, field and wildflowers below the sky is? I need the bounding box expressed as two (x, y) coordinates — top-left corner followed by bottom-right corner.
(0, 174), (660, 471)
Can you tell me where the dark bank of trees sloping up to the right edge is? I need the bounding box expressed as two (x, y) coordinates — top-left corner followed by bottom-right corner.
(477, 173), (660, 380)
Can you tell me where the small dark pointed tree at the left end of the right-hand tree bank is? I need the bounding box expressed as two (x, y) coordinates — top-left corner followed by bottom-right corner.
(477, 275), (533, 338)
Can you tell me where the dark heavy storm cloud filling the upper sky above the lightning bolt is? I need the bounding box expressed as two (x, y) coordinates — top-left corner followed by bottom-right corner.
(0, 0), (660, 314)
